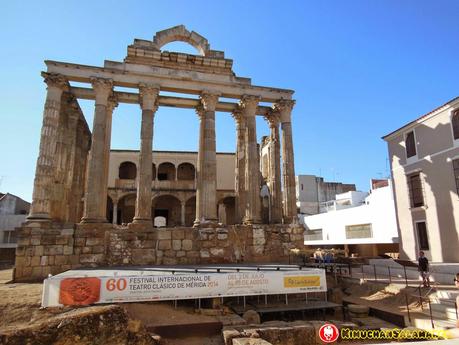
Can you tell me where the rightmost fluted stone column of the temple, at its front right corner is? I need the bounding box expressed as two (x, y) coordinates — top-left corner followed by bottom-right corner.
(274, 99), (298, 224)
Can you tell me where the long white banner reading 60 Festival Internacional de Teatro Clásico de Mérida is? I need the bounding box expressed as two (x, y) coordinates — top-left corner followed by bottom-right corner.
(42, 269), (327, 307)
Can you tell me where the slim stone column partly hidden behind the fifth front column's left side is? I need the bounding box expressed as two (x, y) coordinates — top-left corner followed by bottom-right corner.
(232, 107), (246, 224)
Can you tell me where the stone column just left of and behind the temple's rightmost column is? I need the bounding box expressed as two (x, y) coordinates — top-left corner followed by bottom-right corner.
(266, 112), (282, 224)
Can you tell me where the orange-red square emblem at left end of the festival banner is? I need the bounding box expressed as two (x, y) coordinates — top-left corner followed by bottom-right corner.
(59, 277), (100, 305)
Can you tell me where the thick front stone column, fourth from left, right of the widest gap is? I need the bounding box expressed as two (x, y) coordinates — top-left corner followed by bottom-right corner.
(194, 92), (218, 226)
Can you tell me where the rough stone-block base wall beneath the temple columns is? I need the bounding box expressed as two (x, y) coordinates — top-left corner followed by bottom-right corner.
(14, 222), (304, 281)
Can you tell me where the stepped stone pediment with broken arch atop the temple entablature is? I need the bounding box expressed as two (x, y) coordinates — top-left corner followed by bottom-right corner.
(124, 25), (234, 75)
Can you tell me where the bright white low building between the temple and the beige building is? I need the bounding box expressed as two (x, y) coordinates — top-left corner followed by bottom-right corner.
(300, 180), (398, 256)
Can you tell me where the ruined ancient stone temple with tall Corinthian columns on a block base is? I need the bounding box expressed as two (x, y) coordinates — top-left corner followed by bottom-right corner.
(15, 26), (303, 280)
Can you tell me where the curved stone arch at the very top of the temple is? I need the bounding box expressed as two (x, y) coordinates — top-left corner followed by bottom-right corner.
(153, 25), (210, 56)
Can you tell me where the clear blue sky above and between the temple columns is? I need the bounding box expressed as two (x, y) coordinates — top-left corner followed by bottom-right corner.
(0, 0), (459, 200)
